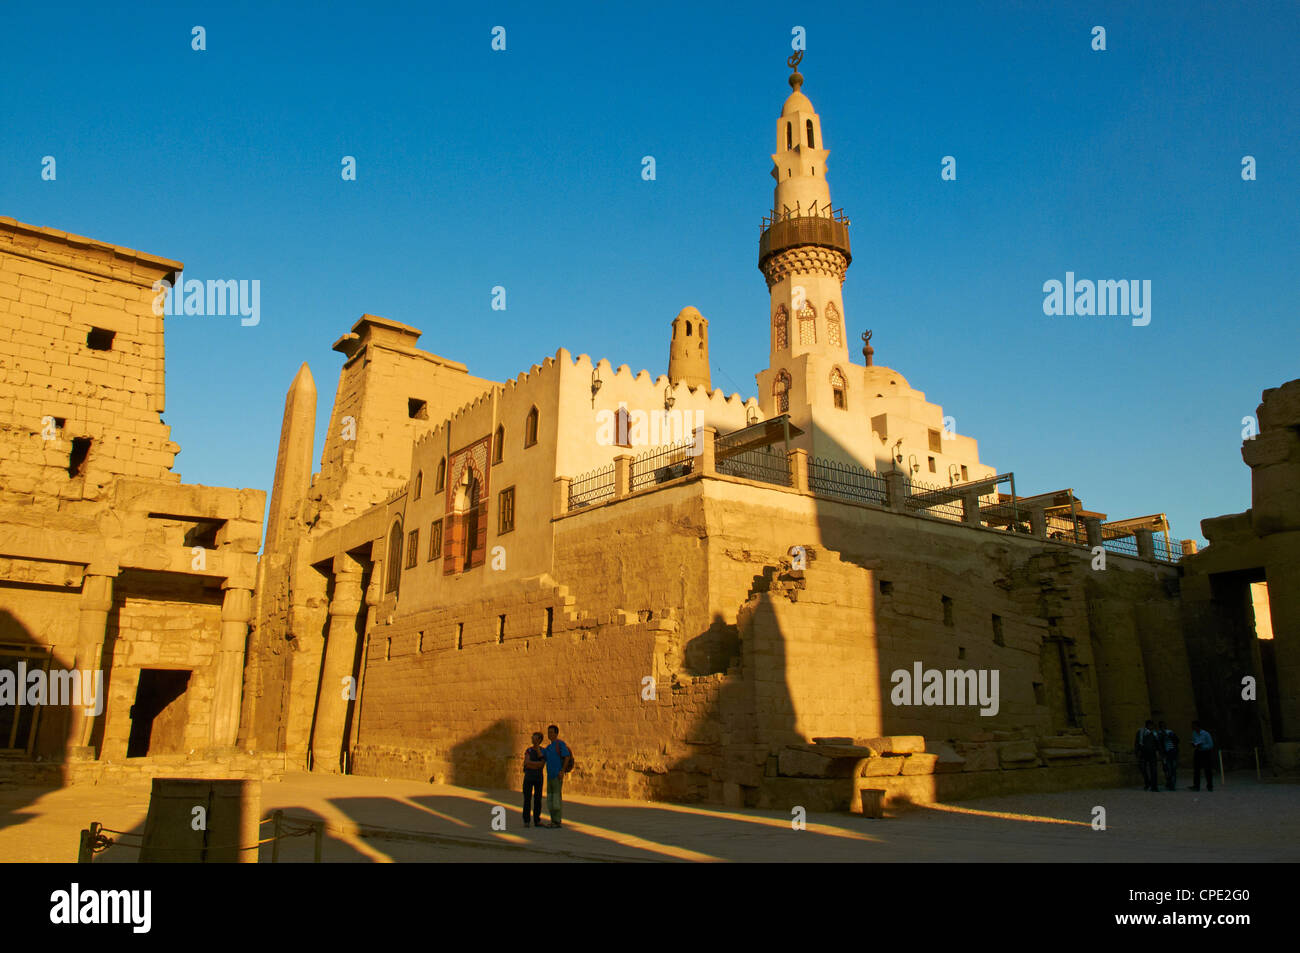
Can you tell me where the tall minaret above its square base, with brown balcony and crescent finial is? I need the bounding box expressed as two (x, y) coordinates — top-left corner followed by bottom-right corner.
(758, 53), (853, 368)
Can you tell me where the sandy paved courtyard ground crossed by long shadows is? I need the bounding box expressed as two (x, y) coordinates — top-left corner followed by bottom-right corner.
(0, 774), (1300, 863)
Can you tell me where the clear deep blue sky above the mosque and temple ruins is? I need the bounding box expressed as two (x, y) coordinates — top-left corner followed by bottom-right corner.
(0, 0), (1300, 538)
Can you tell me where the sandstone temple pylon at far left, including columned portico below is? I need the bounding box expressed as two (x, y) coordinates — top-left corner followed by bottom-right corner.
(0, 218), (267, 763)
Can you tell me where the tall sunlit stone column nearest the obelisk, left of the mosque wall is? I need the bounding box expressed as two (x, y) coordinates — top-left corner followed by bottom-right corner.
(312, 553), (361, 774)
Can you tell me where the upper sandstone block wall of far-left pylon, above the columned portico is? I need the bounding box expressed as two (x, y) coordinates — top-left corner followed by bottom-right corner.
(0, 218), (181, 502)
